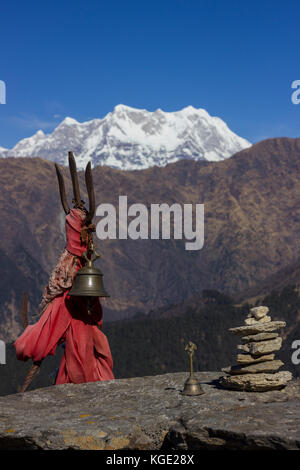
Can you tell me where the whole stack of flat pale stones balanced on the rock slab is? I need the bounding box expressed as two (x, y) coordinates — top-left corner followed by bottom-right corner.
(220, 306), (292, 392)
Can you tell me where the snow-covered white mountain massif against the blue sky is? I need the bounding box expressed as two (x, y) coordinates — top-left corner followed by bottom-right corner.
(0, 104), (251, 170)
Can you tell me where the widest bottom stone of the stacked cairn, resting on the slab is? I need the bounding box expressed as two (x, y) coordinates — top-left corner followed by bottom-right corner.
(219, 371), (292, 392)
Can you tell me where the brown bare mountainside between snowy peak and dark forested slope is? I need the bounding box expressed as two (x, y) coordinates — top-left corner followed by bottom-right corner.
(0, 138), (300, 340)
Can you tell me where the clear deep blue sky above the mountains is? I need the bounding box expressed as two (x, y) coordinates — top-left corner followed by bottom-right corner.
(0, 0), (300, 147)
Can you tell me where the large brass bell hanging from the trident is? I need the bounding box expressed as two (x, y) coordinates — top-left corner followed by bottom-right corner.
(69, 251), (109, 297)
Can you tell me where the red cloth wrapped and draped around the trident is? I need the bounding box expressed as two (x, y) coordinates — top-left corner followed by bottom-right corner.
(14, 208), (114, 384)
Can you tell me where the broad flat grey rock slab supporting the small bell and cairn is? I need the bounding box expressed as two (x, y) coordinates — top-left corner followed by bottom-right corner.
(0, 372), (300, 450)
